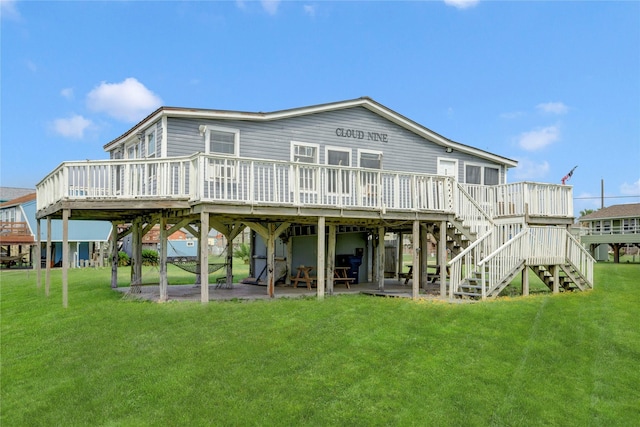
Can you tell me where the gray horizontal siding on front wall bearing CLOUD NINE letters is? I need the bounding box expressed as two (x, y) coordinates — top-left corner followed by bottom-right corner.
(158, 107), (504, 182)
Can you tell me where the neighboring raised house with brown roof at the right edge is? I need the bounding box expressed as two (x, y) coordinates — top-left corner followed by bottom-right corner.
(578, 203), (640, 263)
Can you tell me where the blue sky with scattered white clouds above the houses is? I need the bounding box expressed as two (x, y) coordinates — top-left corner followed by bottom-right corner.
(0, 0), (640, 214)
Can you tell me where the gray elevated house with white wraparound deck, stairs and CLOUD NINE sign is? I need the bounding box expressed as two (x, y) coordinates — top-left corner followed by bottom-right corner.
(37, 98), (593, 302)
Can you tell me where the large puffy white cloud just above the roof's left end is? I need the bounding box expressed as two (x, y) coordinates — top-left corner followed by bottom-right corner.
(87, 77), (162, 122)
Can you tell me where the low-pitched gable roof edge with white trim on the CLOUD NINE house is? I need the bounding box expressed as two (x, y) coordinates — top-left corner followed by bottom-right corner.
(104, 97), (518, 168)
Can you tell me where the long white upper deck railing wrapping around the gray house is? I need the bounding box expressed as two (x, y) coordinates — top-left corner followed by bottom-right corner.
(37, 153), (572, 221)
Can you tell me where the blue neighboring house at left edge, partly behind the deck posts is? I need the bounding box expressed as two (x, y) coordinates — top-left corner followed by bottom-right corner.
(0, 191), (111, 267)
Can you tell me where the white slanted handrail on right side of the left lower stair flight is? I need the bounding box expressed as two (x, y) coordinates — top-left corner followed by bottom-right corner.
(478, 228), (529, 299)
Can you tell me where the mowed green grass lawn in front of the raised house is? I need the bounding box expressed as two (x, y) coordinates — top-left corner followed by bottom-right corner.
(0, 264), (640, 426)
